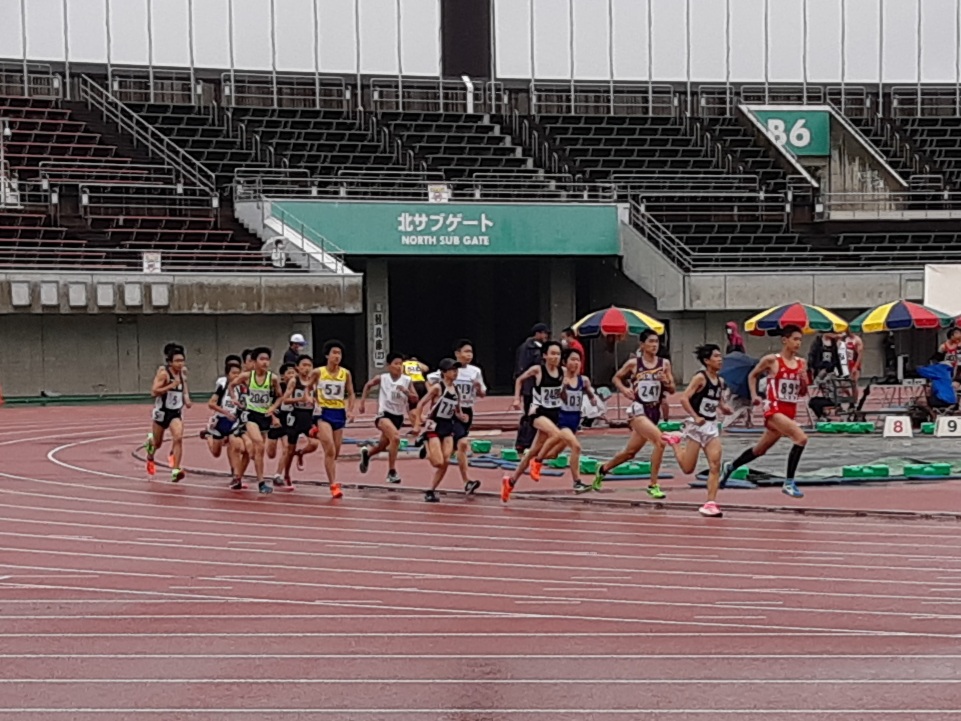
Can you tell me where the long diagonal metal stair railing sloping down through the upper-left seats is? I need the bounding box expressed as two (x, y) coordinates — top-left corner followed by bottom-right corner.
(79, 76), (217, 193)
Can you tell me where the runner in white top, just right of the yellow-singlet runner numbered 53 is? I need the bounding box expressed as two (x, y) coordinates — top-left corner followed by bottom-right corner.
(360, 352), (419, 483)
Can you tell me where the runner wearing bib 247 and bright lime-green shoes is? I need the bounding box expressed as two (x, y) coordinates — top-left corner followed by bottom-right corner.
(594, 330), (678, 499)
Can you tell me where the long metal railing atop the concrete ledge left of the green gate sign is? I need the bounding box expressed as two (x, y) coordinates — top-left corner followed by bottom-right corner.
(0, 241), (332, 272)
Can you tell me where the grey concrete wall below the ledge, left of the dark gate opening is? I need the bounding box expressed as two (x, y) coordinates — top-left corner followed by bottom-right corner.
(0, 314), (312, 401)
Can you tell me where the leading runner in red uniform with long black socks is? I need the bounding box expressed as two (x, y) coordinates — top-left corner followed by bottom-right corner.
(721, 326), (808, 498)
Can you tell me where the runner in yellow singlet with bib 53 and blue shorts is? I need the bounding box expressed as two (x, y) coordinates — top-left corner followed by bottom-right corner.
(311, 340), (354, 498)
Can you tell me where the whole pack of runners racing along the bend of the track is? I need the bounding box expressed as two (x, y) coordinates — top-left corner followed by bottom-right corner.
(144, 327), (807, 516)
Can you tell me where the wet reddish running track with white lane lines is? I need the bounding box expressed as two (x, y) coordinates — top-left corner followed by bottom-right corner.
(0, 407), (961, 721)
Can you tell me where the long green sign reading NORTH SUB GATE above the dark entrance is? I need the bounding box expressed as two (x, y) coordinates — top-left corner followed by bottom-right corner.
(271, 200), (620, 255)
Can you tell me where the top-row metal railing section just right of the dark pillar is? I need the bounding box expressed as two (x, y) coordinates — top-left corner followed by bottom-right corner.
(530, 80), (678, 115)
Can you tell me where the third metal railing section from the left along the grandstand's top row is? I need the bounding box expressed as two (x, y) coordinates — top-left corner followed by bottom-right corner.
(220, 72), (353, 110)
